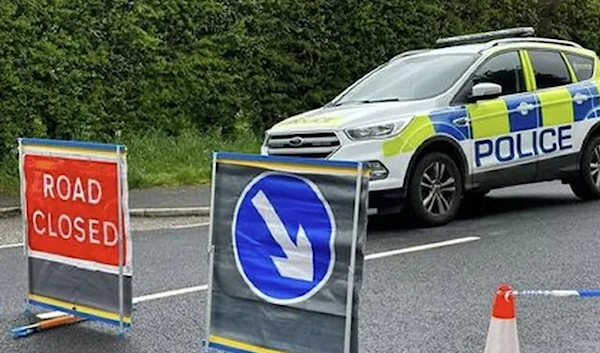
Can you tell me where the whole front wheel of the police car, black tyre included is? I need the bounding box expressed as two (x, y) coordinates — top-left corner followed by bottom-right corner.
(408, 152), (463, 227)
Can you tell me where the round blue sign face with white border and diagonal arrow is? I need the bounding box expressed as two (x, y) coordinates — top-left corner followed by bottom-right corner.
(232, 172), (336, 304)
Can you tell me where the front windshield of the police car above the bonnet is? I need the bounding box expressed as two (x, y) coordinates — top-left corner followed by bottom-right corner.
(334, 54), (477, 105)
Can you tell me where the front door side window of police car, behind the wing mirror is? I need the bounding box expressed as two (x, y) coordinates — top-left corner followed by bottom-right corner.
(471, 51), (527, 95)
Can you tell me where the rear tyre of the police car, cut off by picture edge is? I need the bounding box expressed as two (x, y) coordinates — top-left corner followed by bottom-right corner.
(570, 136), (600, 201)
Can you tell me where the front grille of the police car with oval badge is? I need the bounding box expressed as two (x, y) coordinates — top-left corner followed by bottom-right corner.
(266, 132), (340, 158)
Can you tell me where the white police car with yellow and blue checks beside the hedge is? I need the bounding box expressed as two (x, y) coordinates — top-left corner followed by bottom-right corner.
(261, 27), (600, 226)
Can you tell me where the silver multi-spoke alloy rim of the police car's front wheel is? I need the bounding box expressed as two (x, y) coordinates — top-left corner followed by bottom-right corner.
(421, 162), (458, 216)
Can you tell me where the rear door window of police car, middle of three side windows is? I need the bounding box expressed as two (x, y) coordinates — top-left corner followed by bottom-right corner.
(528, 50), (572, 89)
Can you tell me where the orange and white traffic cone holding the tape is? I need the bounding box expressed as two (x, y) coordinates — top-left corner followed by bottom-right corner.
(484, 284), (519, 353)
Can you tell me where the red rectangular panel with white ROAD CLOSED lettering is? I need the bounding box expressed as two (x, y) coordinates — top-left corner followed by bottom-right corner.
(23, 154), (127, 266)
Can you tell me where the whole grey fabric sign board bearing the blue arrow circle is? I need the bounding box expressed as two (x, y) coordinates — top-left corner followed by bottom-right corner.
(206, 153), (369, 353)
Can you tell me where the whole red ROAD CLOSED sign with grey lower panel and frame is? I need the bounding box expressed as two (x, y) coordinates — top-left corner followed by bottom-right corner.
(20, 139), (132, 327)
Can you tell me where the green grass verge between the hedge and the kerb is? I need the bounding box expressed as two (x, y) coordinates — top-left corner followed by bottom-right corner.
(0, 132), (262, 195)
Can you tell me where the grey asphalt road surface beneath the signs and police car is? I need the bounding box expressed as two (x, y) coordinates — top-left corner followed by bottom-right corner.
(0, 183), (600, 353)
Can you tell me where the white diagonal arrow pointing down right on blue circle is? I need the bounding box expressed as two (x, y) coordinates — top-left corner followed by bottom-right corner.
(252, 190), (314, 282)
